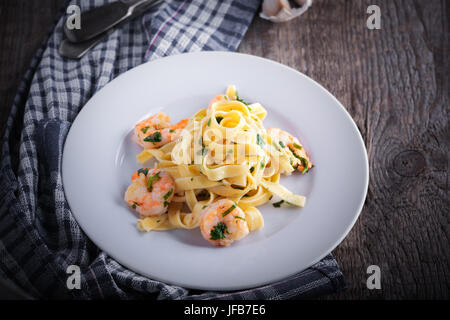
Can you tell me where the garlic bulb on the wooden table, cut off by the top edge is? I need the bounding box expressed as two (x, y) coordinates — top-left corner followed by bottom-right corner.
(259, 0), (312, 22)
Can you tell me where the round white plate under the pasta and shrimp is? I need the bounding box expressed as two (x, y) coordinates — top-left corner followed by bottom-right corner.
(63, 52), (368, 290)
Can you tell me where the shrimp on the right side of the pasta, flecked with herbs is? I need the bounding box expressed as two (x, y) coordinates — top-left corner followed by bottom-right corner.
(267, 128), (313, 173)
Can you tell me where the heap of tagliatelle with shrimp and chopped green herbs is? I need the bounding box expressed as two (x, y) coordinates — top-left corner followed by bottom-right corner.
(125, 86), (313, 245)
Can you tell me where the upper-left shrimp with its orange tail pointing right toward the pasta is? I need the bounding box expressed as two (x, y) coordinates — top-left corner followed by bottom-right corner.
(134, 112), (189, 149)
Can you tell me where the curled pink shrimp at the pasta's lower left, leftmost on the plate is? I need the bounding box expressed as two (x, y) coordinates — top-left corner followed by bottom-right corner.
(125, 168), (175, 217)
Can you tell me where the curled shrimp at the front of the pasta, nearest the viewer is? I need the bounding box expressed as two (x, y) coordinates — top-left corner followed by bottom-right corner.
(200, 199), (249, 247)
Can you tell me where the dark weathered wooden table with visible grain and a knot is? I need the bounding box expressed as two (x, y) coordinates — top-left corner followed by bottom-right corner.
(0, 0), (450, 299)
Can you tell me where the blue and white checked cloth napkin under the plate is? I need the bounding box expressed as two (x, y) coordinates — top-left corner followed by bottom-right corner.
(0, 0), (345, 299)
